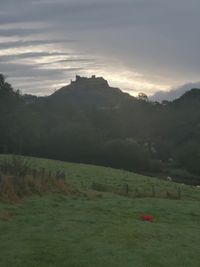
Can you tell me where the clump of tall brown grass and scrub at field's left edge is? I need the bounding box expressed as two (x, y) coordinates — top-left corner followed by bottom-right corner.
(0, 155), (71, 202)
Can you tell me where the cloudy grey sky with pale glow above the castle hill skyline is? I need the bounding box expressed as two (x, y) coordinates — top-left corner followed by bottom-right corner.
(0, 0), (200, 95)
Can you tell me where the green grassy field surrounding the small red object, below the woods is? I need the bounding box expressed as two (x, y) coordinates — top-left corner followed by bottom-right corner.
(0, 156), (200, 267)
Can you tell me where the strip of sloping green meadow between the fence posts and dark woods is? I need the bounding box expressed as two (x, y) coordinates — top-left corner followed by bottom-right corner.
(0, 155), (200, 200)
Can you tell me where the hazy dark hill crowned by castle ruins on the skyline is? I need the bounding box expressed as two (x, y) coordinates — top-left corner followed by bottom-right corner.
(48, 75), (133, 108)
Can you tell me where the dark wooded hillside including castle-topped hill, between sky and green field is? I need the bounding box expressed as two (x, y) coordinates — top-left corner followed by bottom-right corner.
(0, 75), (200, 184)
